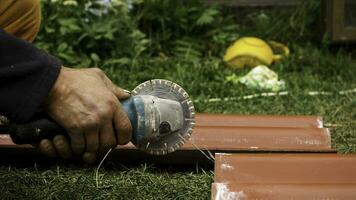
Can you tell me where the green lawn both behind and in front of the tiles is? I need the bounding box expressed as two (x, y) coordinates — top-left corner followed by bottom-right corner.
(0, 0), (356, 199)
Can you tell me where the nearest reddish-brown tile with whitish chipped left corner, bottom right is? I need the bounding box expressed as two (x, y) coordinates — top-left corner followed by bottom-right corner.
(211, 153), (356, 200)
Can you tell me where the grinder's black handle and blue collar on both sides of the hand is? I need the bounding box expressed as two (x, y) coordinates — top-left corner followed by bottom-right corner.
(8, 97), (136, 144)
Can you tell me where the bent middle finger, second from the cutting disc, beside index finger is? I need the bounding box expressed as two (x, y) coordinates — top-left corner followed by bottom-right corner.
(99, 120), (117, 154)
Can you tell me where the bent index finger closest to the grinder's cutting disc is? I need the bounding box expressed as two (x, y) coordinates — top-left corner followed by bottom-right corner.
(113, 104), (132, 145)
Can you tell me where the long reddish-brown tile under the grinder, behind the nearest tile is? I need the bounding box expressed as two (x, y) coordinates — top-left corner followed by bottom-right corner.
(0, 114), (333, 163)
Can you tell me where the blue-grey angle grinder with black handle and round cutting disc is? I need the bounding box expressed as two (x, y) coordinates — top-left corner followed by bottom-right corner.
(0, 79), (195, 155)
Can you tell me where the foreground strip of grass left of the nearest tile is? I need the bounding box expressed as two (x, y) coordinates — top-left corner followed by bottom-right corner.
(0, 165), (212, 199)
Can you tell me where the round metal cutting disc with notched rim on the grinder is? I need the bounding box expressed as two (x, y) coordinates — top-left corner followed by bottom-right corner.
(132, 79), (195, 155)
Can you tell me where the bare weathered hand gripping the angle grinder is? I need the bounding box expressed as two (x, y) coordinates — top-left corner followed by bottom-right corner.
(39, 67), (132, 163)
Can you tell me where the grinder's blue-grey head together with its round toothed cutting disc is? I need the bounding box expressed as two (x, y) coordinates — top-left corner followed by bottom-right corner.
(126, 79), (195, 155)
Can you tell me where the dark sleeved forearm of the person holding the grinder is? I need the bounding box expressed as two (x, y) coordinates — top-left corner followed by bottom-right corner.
(0, 29), (61, 122)
